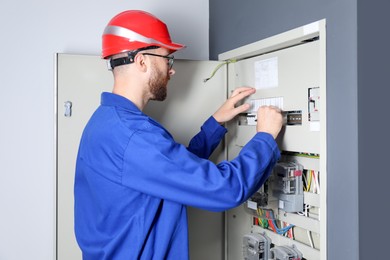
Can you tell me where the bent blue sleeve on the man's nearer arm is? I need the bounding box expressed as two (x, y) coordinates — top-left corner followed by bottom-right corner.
(121, 121), (280, 211)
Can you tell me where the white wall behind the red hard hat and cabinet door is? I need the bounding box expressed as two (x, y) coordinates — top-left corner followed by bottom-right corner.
(0, 0), (209, 260)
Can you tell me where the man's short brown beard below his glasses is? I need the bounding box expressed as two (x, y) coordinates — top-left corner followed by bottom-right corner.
(149, 65), (170, 101)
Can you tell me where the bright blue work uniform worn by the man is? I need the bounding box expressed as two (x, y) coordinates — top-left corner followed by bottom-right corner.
(74, 93), (280, 260)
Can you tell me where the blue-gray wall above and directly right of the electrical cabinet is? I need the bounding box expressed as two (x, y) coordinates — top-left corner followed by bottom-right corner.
(209, 0), (360, 260)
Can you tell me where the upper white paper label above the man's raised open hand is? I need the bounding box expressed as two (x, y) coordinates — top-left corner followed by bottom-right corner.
(255, 57), (279, 89)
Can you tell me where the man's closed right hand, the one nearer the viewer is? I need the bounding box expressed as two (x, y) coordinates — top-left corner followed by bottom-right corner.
(256, 106), (283, 139)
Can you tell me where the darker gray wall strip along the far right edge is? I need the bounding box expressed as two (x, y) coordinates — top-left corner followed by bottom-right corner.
(357, 0), (390, 260)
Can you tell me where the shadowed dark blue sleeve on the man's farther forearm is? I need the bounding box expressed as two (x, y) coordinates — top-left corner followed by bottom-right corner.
(187, 116), (227, 159)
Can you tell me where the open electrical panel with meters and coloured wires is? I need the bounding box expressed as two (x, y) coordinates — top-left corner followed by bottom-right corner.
(220, 21), (326, 260)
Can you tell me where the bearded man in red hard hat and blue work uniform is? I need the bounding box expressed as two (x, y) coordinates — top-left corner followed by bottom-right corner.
(75, 11), (282, 260)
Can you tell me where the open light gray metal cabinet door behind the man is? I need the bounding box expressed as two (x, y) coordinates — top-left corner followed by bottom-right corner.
(56, 54), (227, 260)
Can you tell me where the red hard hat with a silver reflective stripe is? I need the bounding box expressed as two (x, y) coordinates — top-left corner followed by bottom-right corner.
(102, 10), (185, 59)
